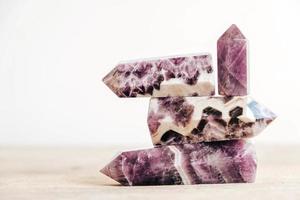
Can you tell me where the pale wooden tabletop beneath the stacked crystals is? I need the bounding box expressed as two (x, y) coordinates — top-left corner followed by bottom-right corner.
(0, 145), (300, 200)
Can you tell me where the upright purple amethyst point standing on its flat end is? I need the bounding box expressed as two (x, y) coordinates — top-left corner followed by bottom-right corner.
(217, 24), (249, 96)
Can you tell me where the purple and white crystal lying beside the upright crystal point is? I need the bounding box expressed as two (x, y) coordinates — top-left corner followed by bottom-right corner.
(103, 54), (215, 97)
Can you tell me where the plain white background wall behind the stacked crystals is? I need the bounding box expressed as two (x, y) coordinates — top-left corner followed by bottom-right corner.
(0, 0), (300, 146)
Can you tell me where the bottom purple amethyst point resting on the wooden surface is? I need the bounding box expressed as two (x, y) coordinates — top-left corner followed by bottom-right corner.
(101, 140), (256, 185)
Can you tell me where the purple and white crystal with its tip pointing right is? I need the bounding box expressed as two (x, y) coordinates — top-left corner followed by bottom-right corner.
(147, 96), (276, 145)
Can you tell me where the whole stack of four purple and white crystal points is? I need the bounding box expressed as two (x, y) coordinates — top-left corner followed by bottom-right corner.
(101, 25), (276, 185)
